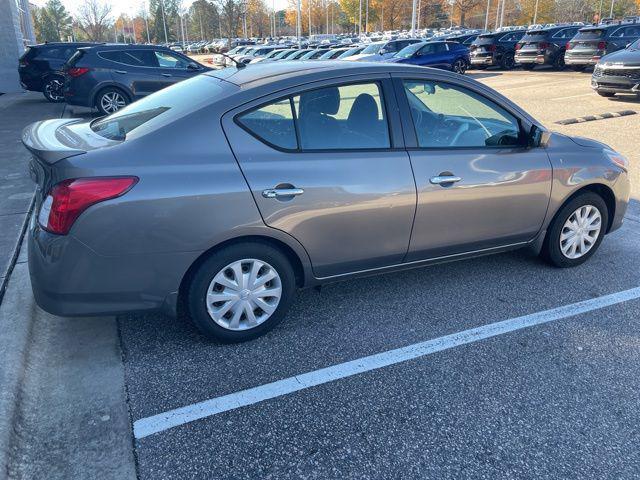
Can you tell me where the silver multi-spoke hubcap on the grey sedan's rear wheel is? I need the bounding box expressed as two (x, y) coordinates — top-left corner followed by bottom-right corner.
(206, 258), (282, 330)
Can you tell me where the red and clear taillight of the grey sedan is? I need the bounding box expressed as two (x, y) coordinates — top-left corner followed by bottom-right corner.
(38, 177), (138, 235)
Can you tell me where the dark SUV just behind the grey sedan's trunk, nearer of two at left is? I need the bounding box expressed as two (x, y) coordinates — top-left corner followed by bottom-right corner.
(64, 44), (210, 115)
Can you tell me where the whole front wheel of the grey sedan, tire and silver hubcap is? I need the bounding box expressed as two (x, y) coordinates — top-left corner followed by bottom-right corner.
(542, 192), (609, 268)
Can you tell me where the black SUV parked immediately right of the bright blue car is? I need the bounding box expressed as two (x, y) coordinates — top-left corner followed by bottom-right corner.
(469, 29), (526, 70)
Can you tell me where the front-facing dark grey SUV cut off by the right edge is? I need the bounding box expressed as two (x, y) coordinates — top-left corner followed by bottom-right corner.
(591, 40), (640, 97)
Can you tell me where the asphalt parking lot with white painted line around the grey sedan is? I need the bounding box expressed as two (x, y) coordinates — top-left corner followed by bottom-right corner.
(5, 70), (640, 479)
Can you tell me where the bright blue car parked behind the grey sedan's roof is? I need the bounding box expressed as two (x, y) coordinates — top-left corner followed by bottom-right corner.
(387, 42), (471, 75)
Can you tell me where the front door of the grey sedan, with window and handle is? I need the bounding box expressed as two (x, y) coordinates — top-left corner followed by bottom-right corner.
(394, 74), (552, 261)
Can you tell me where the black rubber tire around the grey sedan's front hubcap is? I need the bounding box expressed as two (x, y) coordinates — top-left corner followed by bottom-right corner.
(541, 192), (609, 268)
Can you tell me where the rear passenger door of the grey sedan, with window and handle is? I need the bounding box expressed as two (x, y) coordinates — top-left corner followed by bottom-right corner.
(222, 74), (416, 277)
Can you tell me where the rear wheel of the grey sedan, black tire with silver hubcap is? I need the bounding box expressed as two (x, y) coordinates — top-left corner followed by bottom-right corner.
(186, 242), (296, 343)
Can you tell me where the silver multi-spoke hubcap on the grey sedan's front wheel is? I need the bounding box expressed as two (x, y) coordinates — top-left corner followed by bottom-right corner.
(560, 205), (602, 259)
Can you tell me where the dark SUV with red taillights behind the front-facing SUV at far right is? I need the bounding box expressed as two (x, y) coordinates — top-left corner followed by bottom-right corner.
(564, 19), (640, 70)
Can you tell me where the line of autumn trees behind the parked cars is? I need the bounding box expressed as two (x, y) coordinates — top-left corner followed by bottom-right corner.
(31, 0), (640, 43)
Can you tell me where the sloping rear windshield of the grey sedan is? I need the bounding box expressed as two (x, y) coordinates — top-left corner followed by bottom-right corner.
(91, 75), (223, 141)
